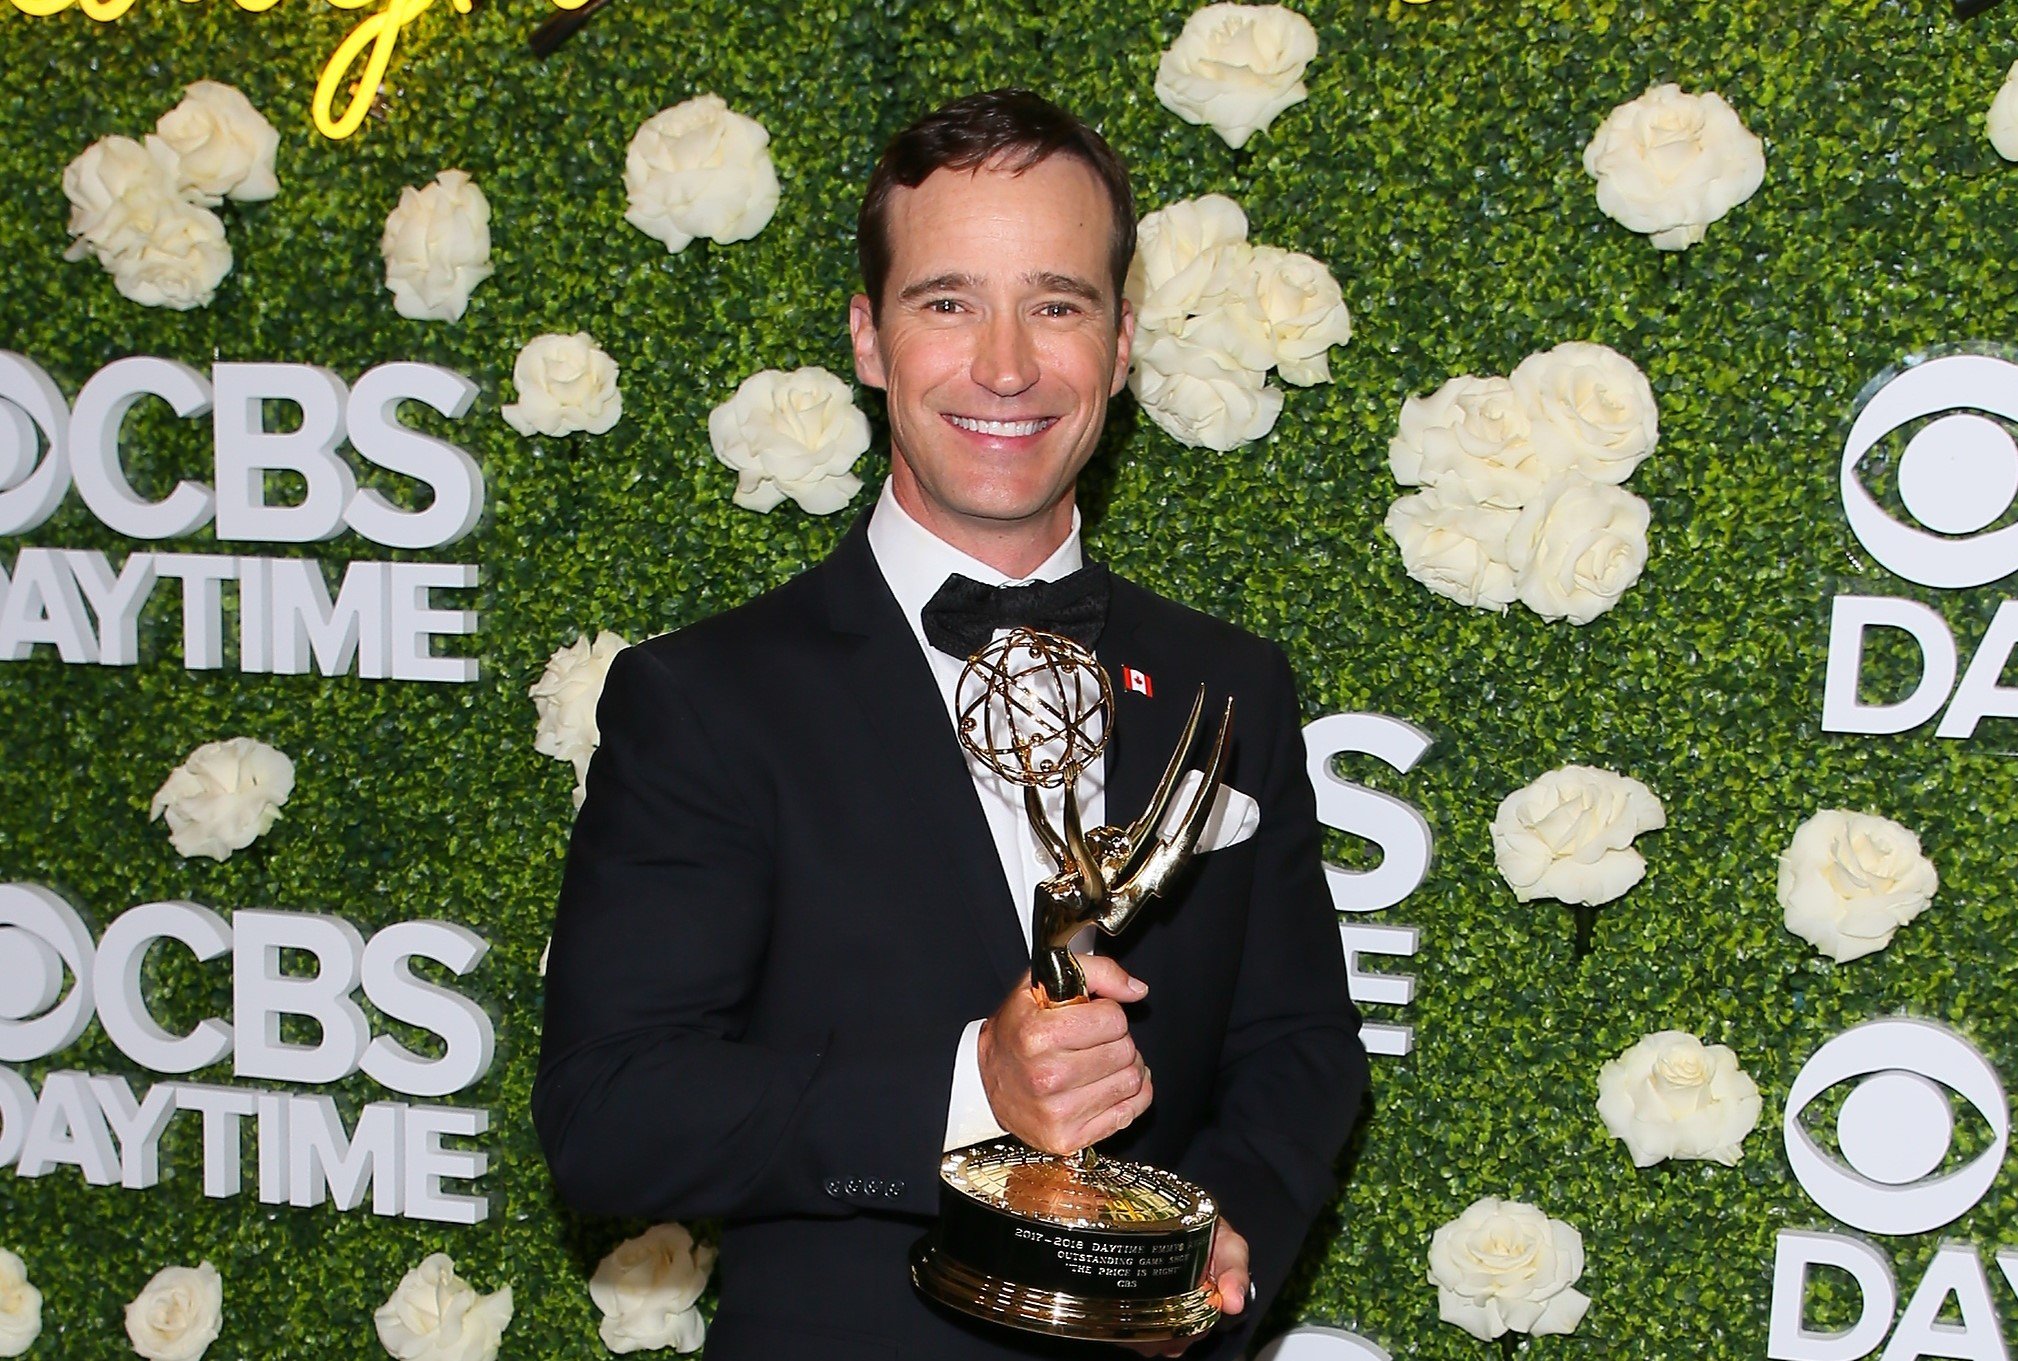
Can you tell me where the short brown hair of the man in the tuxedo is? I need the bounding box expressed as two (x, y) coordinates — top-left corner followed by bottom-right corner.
(856, 89), (1134, 325)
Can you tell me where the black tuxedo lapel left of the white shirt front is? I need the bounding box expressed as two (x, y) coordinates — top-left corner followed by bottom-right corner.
(821, 515), (1029, 991)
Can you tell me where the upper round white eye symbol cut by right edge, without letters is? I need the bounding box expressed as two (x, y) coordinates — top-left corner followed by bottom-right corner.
(1840, 355), (2018, 590)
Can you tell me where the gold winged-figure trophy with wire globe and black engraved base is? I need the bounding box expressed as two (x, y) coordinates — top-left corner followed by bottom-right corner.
(910, 628), (1233, 1343)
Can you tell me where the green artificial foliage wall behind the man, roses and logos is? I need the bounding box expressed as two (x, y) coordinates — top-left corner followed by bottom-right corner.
(0, 0), (2018, 1361)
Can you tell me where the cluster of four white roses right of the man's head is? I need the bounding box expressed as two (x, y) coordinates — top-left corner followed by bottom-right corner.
(1384, 341), (1659, 624)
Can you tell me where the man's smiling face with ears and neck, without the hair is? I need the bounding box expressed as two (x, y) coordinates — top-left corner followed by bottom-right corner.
(848, 155), (1134, 571)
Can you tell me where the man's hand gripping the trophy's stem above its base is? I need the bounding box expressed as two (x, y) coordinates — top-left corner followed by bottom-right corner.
(977, 955), (1150, 1153)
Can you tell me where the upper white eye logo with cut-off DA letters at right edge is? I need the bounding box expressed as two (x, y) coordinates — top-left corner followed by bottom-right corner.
(1822, 353), (2018, 737)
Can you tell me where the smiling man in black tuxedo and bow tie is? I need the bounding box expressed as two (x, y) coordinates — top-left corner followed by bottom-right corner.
(533, 91), (1366, 1361)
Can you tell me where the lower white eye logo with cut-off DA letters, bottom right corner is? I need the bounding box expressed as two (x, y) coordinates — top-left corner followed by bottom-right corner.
(1766, 1018), (2018, 1361)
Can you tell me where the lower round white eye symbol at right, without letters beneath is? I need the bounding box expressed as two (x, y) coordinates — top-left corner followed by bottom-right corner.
(1780, 1020), (2012, 1236)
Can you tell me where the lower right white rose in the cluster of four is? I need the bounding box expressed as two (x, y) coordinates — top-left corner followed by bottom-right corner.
(1507, 477), (1651, 624)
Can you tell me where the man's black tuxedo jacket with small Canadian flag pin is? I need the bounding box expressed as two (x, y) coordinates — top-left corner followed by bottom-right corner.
(533, 517), (1366, 1361)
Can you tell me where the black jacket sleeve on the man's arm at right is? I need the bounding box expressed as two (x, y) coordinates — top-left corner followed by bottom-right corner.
(1179, 646), (1368, 1359)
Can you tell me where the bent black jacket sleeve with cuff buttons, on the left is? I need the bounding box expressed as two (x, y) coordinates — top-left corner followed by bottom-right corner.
(533, 646), (959, 1218)
